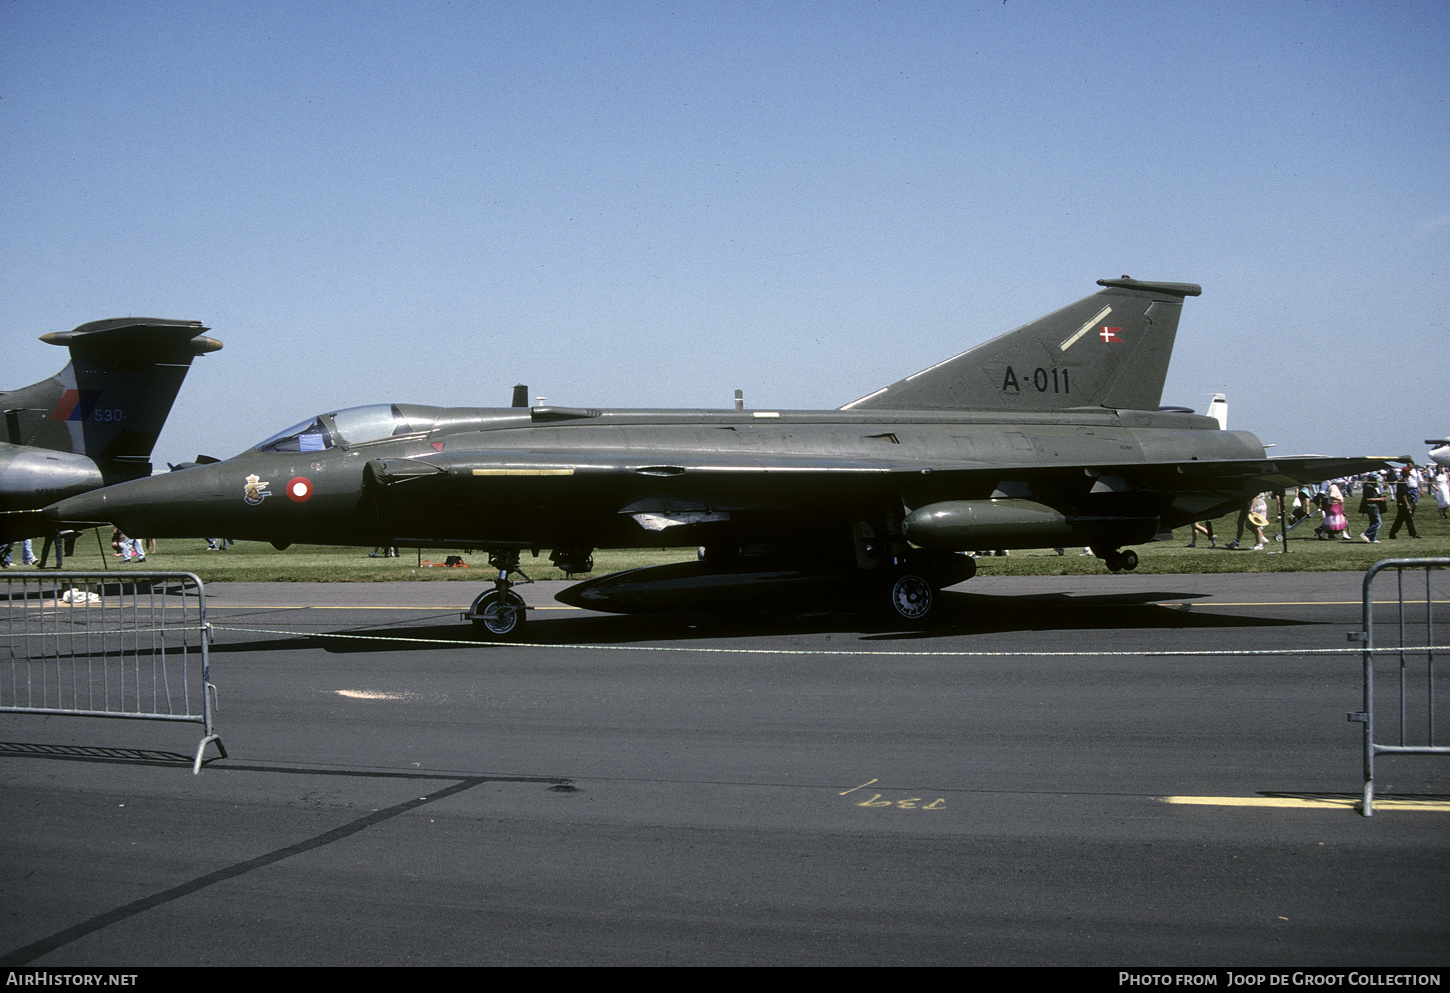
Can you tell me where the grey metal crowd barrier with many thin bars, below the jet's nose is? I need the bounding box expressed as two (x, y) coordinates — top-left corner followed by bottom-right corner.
(0, 571), (226, 773)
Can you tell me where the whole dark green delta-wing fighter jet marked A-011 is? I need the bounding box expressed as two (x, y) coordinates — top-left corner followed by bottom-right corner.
(46, 277), (1385, 636)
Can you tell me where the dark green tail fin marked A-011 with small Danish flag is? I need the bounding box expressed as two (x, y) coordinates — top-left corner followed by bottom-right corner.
(842, 277), (1202, 412)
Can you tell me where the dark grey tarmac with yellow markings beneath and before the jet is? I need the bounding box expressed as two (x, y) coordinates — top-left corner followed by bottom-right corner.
(0, 573), (1450, 967)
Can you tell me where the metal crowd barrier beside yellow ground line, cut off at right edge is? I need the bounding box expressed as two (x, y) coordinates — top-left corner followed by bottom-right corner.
(1349, 558), (1450, 818)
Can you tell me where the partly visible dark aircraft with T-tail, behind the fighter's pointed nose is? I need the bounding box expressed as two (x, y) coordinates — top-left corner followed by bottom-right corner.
(0, 317), (222, 542)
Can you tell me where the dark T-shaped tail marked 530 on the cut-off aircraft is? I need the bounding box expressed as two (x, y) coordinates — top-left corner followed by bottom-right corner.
(0, 317), (222, 475)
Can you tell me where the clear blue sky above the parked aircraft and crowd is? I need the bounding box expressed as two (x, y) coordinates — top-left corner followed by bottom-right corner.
(0, 0), (1450, 461)
